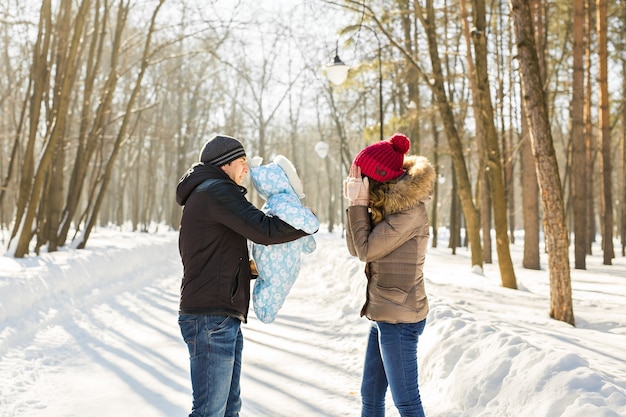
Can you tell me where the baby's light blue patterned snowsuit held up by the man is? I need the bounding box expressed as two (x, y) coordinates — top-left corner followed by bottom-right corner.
(250, 155), (319, 323)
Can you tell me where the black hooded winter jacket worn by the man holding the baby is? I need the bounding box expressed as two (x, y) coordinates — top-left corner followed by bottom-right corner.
(176, 163), (306, 322)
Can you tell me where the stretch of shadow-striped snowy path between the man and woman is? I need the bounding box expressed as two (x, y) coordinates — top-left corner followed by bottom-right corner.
(236, 231), (370, 417)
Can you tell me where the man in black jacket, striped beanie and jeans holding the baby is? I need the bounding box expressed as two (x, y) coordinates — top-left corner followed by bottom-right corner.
(176, 135), (306, 417)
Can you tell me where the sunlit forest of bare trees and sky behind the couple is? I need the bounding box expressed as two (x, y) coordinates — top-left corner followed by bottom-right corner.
(0, 0), (626, 325)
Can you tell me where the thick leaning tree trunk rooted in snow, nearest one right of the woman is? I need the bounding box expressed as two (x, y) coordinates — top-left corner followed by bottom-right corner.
(510, 0), (574, 325)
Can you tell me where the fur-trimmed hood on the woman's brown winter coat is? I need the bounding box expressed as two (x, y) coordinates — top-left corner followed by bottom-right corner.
(376, 155), (437, 215)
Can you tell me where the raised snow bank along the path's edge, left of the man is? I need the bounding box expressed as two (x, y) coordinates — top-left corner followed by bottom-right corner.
(0, 229), (182, 346)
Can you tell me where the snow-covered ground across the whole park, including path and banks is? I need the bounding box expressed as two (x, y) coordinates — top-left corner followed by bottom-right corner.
(0, 229), (626, 417)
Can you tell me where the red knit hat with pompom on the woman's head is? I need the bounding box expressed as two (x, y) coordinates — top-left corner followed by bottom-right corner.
(352, 133), (411, 182)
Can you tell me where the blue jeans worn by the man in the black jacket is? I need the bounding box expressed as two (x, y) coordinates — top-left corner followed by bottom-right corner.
(178, 314), (243, 417)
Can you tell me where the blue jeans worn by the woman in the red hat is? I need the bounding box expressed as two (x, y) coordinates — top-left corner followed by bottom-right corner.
(361, 319), (426, 417)
